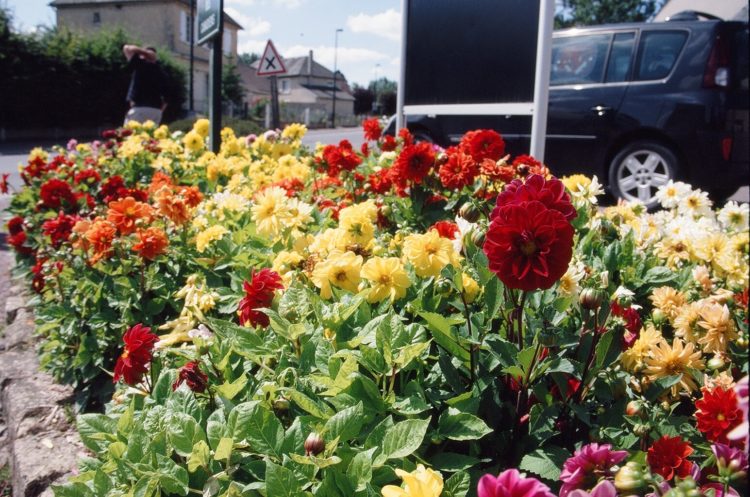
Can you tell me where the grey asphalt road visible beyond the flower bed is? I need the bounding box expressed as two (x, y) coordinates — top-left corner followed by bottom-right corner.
(0, 127), (750, 202)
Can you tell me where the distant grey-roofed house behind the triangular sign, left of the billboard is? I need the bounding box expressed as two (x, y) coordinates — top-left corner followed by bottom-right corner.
(240, 50), (356, 127)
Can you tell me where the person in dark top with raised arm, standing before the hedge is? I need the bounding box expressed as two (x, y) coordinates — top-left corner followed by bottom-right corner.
(122, 45), (167, 125)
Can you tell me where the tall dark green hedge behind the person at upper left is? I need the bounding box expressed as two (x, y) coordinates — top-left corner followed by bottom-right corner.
(0, 9), (186, 128)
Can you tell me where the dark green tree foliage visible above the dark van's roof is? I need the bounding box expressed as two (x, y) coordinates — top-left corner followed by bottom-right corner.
(555, 0), (665, 28)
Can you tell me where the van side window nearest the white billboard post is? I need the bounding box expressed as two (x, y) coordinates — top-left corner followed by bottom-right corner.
(550, 34), (612, 86)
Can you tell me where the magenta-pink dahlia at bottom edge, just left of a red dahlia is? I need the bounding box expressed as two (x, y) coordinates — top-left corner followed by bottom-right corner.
(560, 443), (628, 497)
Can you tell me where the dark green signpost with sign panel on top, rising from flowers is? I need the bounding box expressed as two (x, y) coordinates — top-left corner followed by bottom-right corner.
(198, 0), (224, 153)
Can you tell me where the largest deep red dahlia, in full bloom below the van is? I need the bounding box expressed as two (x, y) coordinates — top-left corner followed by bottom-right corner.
(484, 201), (573, 291)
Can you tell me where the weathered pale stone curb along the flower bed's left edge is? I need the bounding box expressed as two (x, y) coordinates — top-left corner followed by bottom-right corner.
(0, 252), (86, 497)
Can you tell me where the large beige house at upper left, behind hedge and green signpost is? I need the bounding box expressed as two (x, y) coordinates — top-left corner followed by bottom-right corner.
(50, 0), (242, 113)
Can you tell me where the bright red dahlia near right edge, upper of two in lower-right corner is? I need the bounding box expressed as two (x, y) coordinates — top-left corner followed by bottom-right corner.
(695, 386), (742, 444)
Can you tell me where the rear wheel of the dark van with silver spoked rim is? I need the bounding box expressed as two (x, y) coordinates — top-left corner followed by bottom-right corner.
(609, 140), (680, 209)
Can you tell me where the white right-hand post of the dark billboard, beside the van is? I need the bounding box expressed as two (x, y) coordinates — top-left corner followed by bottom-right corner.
(530, 0), (555, 162)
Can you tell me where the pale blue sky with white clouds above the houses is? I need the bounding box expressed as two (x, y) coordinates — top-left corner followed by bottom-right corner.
(0, 0), (401, 86)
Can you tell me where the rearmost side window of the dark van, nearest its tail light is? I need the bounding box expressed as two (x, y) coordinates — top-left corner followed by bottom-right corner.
(635, 31), (687, 81)
